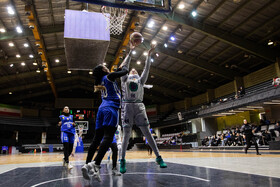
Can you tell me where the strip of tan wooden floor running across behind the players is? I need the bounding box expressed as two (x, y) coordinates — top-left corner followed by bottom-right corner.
(0, 150), (280, 165)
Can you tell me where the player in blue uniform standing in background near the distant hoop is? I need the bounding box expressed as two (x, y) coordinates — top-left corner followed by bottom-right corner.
(58, 106), (76, 169)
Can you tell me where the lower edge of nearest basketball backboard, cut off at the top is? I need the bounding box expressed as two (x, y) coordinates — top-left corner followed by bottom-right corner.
(74, 0), (171, 13)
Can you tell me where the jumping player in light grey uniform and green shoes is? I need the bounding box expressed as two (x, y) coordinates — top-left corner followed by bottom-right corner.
(120, 42), (167, 173)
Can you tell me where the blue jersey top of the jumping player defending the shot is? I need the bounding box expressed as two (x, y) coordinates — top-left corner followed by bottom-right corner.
(99, 75), (121, 108)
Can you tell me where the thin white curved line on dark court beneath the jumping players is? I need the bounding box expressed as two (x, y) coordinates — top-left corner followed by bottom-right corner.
(31, 172), (210, 187)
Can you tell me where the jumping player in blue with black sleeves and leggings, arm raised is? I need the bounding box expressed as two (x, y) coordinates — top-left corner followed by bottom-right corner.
(82, 45), (134, 181)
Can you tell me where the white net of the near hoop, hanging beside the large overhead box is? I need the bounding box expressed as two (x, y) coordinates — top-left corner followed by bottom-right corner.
(101, 6), (128, 35)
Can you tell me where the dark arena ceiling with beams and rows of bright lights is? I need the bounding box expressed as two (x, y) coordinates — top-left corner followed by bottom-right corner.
(0, 0), (280, 104)
